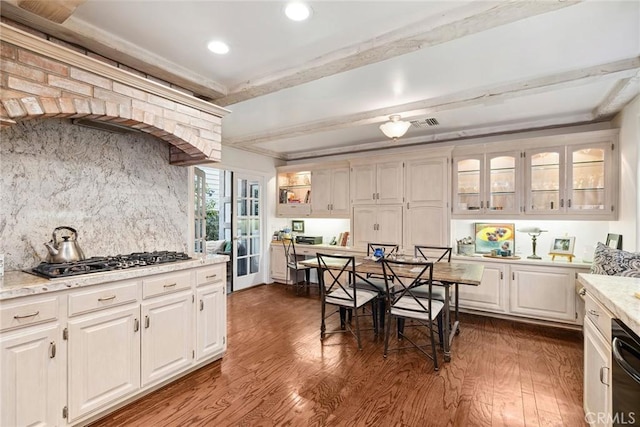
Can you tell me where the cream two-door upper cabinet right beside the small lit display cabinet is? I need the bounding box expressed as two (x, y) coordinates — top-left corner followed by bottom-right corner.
(311, 166), (350, 218)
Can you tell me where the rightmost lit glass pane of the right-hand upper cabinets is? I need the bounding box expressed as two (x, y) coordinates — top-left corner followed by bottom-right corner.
(568, 148), (605, 210)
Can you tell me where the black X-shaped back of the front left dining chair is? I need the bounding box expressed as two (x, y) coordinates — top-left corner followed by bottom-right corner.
(316, 253), (357, 307)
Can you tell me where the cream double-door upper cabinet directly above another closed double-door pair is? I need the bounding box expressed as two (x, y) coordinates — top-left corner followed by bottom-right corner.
(350, 160), (404, 205)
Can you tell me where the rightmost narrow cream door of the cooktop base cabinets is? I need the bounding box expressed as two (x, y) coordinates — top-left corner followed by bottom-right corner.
(196, 283), (227, 361)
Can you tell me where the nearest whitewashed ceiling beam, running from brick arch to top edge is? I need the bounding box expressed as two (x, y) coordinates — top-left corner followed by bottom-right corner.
(214, 0), (582, 106)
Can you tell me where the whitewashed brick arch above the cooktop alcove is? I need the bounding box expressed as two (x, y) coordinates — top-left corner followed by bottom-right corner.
(0, 22), (222, 165)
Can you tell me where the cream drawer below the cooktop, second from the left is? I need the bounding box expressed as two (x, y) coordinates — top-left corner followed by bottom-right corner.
(69, 281), (139, 316)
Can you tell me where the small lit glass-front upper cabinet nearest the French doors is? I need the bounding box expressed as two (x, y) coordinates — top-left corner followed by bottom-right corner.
(277, 171), (311, 217)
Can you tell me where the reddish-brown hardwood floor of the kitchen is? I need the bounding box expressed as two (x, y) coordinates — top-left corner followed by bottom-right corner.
(93, 284), (586, 427)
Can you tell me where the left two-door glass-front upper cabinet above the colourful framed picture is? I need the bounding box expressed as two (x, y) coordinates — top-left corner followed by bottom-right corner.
(453, 152), (520, 215)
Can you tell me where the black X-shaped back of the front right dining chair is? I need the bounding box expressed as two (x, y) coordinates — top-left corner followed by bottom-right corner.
(382, 258), (433, 318)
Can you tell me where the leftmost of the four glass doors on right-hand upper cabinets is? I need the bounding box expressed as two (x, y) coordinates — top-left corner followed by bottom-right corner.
(454, 157), (484, 213)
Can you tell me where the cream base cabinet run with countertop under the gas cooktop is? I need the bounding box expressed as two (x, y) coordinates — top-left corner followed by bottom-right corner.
(0, 255), (228, 426)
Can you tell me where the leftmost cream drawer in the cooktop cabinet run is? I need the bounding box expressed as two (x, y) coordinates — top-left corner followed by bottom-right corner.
(0, 297), (58, 331)
